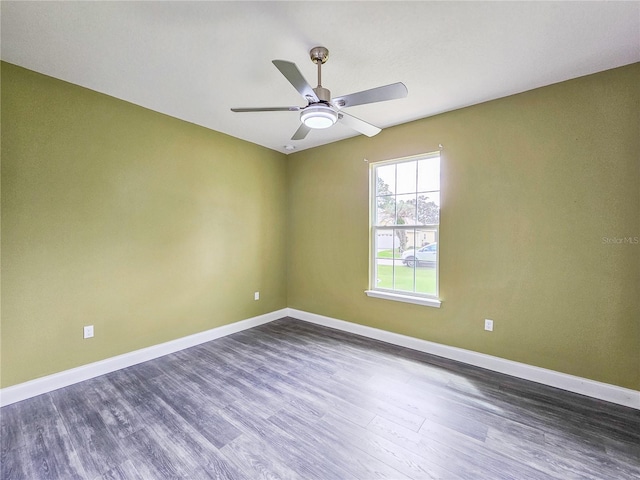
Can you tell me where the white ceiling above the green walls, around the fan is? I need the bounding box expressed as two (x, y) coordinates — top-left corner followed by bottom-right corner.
(0, 1), (640, 153)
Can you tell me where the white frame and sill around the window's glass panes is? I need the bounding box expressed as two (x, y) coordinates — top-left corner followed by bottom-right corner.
(365, 151), (442, 308)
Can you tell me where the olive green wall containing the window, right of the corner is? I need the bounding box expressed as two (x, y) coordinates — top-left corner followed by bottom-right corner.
(287, 64), (640, 389)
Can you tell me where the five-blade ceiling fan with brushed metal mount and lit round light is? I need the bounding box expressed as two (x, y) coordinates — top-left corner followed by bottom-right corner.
(231, 47), (408, 140)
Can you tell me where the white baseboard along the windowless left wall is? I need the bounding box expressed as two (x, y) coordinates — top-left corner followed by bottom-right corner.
(0, 308), (287, 406)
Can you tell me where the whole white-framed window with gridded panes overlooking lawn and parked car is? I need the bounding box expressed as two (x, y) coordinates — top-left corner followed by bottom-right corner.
(366, 152), (440, 307)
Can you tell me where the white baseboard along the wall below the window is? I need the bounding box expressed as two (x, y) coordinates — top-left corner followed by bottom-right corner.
(287, 308), (640, 409)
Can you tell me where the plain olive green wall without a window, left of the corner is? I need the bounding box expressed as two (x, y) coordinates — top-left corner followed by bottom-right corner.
(1, 63), (287, 387)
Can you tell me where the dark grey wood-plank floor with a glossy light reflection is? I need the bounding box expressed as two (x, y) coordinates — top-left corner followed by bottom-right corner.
(1, 318), (640, 480)
